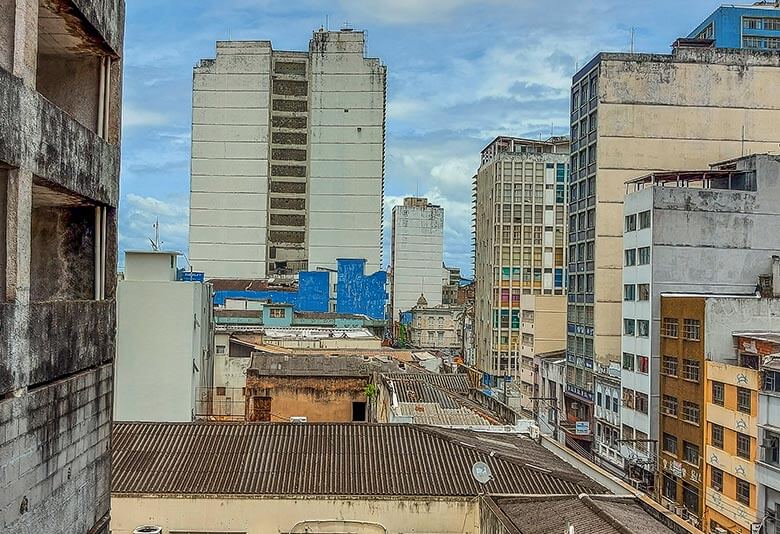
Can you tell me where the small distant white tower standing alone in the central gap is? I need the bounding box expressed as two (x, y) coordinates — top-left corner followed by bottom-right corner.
(391, 197), (444, 321)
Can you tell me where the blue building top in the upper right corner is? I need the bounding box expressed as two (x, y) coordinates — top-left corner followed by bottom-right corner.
(688, 2), (780, 51)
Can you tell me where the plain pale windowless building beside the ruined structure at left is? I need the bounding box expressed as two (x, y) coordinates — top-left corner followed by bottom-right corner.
(114, 252), (212, 421)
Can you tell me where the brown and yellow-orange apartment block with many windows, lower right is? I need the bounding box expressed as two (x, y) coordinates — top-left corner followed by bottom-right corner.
(656, 293), (780, 532)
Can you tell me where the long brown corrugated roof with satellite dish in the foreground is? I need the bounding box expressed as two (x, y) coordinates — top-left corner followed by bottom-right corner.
(112, 422), (603, 496)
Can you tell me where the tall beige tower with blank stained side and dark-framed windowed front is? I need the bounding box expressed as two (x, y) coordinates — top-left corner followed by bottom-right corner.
(566, 46), (780, 456)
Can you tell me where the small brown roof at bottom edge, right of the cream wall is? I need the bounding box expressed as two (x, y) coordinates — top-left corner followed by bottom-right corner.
(488, 495), (674, 534)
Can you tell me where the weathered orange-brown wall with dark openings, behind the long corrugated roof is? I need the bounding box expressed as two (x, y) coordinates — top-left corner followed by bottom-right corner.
(246, 371), (369, 423)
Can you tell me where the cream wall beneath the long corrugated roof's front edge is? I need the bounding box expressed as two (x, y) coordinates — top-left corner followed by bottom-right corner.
(111, 496), (479, 534)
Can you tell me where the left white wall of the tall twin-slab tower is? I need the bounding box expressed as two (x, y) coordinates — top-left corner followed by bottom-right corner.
(190, 41), (271, 278)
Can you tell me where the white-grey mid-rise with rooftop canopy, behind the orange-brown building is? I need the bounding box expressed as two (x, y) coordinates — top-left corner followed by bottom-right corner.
(595, 155), (780, 486)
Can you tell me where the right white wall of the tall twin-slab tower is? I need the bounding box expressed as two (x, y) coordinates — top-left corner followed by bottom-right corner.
(307, 31), (386, 273)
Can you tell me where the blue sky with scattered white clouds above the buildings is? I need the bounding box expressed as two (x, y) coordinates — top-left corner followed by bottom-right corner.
(119, 0), (718, 276)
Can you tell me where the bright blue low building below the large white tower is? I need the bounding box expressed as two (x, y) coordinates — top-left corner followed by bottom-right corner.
(214, 259), (387, 320)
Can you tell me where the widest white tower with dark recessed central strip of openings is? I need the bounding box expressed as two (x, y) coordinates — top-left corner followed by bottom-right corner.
(190, 30), (386, 278)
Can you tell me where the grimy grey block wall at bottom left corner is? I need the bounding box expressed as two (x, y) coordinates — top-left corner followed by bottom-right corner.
(0, 364), (112, 534)
